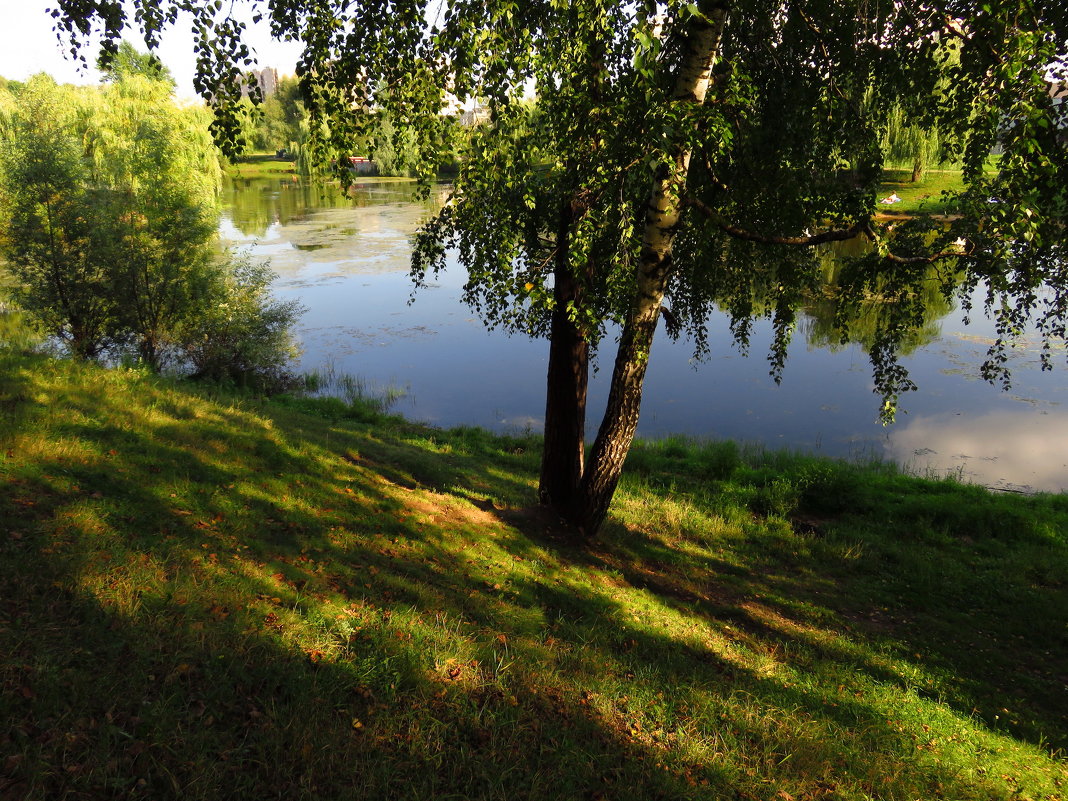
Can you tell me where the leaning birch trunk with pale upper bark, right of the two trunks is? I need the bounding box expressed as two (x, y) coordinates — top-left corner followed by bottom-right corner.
(569, 0), (727, 536)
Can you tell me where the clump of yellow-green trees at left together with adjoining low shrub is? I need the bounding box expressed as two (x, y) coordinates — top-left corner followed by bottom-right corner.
(0, 69), (299, 390)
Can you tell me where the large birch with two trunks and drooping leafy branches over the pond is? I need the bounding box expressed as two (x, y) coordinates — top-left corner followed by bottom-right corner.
(57, 0), (1068, 535)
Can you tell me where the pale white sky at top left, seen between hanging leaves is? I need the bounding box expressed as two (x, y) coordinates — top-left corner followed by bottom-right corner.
(0, 0), (300, 99)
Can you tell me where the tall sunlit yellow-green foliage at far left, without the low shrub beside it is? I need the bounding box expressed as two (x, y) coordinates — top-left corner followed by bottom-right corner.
(0, 73), (219, 367)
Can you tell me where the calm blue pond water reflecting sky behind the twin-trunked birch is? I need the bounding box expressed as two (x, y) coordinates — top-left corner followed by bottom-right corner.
(221, 180), (1068, 491)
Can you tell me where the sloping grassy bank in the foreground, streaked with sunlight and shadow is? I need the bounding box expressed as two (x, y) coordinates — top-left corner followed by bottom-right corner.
(0, 351), (1068, 801)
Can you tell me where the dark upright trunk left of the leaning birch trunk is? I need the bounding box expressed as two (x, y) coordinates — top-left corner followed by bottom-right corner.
(538, 198), (590, 519)
